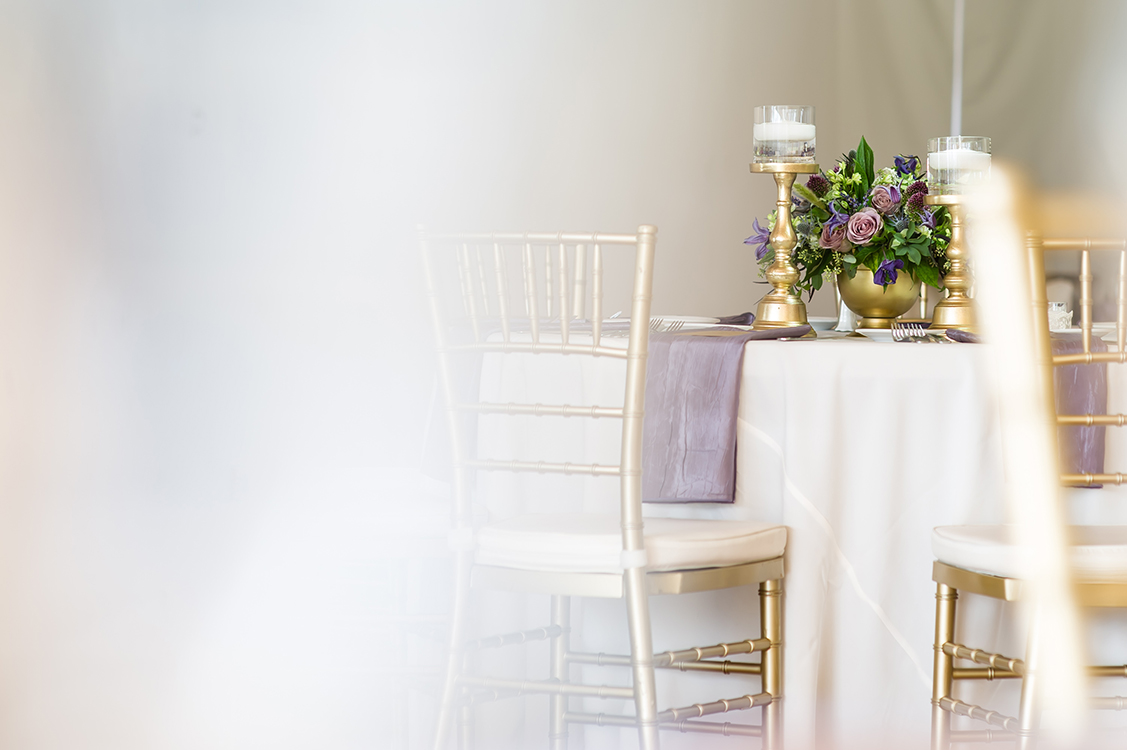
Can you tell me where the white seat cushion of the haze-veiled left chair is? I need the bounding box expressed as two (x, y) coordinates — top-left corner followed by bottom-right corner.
(476, 513), (787, 573)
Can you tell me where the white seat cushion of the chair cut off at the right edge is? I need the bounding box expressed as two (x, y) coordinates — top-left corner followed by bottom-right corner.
(931, 526), (1127, 583)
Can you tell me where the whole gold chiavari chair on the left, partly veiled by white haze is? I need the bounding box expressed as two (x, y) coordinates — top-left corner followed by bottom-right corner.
(420, 226), (787, 750)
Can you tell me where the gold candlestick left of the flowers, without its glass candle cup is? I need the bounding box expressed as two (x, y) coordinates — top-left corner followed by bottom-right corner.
(751, 162), (818, 336)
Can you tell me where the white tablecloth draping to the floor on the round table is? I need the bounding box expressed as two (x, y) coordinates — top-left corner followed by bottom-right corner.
(473, 338), (1127, 748)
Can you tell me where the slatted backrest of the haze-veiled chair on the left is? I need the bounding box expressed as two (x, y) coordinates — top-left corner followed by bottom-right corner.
(419, 226), (657, 543)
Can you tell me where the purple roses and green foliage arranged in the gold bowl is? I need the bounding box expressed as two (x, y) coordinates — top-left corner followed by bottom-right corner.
(744, 138), (951, 295)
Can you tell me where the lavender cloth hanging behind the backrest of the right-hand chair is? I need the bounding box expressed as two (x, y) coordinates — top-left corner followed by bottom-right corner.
(1053, 334), (1108, 482)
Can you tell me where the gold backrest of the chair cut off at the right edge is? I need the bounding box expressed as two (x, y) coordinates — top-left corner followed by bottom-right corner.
(1030, 235), (1127, 486)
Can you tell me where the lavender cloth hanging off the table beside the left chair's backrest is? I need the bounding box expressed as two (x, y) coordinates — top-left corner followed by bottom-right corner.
(642, 326), (809, 503)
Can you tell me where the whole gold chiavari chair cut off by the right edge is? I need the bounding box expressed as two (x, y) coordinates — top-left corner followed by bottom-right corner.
(932, 191), (1127, 750)
